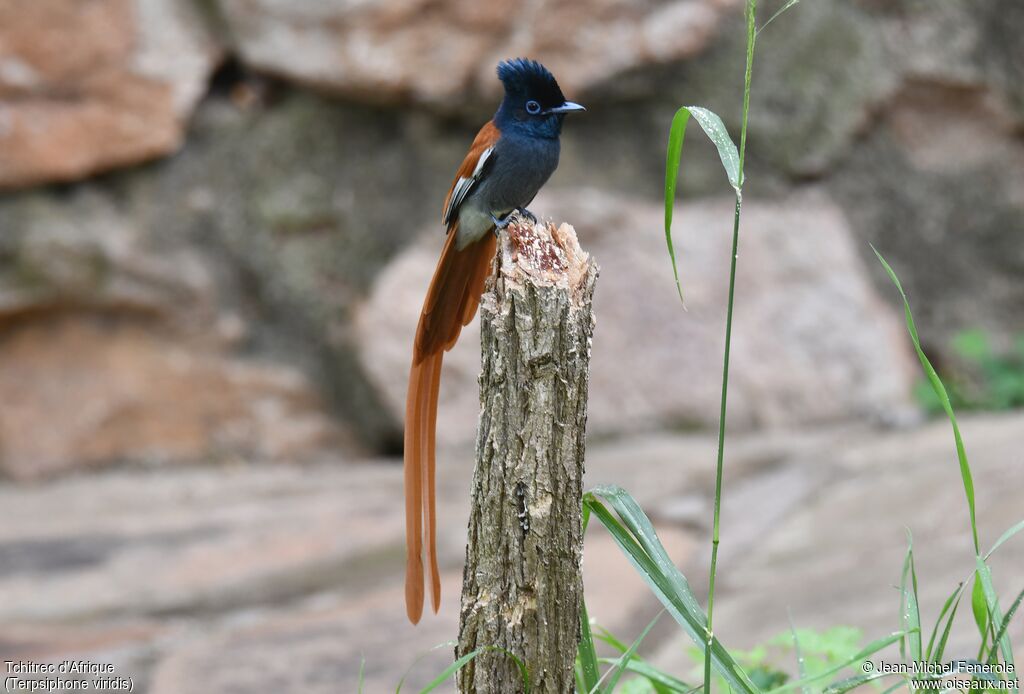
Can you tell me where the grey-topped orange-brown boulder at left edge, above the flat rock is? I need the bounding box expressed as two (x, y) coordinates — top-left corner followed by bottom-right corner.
(0, 188), (348, 479)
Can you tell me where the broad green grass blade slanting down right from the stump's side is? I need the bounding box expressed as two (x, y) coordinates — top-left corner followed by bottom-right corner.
(584, 487), (759, 694)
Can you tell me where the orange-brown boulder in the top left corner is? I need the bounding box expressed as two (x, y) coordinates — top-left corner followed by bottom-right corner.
(0, 0), (220, 188)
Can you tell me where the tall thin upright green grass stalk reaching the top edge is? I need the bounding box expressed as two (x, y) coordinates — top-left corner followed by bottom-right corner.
(703, 0), (758, 694)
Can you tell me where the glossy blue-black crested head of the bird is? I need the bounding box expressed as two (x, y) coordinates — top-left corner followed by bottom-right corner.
(495, 58), (584, 138)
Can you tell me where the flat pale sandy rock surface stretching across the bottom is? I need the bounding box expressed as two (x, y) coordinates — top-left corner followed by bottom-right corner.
(0, 415), (1024, 694)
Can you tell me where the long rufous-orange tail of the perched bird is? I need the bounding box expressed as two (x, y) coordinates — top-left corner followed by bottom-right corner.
(404, 224), (495, 624)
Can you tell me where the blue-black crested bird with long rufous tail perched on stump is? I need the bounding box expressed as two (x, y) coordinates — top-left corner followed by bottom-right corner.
(404, 58), (584, 624)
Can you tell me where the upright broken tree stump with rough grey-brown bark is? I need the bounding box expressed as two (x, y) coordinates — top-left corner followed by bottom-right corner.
(456, 220), (598, 694)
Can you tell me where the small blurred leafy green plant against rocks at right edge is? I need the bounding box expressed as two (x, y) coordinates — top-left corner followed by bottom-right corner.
(914, 330), (1024, 414)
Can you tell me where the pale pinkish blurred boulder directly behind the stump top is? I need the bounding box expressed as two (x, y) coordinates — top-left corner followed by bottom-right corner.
(357, 189), (916, 444)
